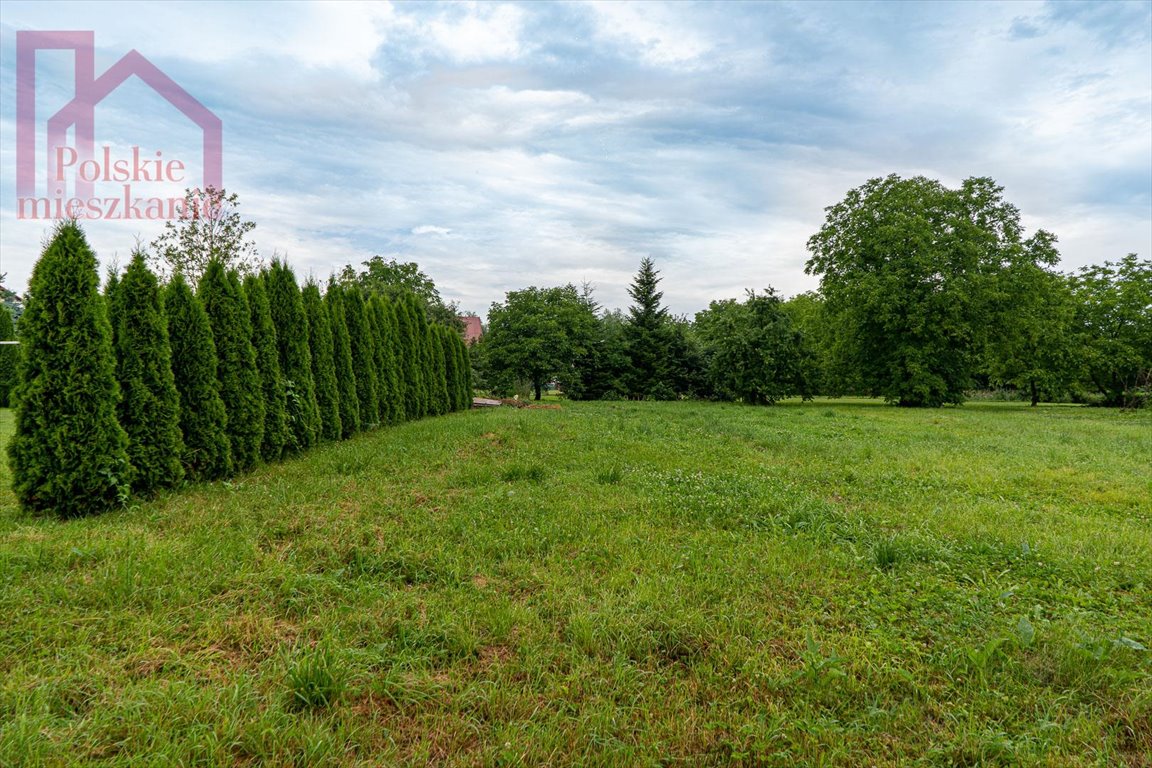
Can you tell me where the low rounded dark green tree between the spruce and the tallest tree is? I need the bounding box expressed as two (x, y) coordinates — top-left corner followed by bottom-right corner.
(696, 289), (810, 405)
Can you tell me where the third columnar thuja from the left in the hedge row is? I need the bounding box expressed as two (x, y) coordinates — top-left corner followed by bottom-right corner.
(164, 272), (232, 480)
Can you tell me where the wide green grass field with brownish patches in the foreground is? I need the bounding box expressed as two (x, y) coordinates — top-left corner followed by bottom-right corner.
(0, 401), (1152, 766)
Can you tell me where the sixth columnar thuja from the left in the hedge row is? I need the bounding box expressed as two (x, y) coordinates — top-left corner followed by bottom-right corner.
(264, 259), (320, 450)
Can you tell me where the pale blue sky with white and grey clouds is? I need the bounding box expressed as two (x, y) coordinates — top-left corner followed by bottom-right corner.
(0, 0), (1152, 314)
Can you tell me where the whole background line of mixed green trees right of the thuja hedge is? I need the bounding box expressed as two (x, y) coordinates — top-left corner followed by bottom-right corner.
(473, 175), (1152, 406)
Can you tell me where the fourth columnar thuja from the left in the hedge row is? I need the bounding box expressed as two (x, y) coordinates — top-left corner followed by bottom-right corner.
(197, 259), (265, 472)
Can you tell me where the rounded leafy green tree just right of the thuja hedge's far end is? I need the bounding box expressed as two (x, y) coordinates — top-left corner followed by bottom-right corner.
(479, 284), (596, 400)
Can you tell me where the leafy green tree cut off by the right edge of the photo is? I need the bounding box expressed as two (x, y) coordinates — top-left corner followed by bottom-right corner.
(1069, 253), (1152, 405)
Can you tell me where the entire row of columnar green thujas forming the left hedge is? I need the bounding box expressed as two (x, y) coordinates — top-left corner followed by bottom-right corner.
(8, 222), (471, 517)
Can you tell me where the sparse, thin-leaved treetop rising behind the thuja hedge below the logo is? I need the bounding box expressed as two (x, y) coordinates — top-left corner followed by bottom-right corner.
(151, 187), (260, 284)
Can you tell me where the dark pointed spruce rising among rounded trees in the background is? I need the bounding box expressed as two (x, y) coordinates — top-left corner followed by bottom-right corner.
(624, 258), (677, 400)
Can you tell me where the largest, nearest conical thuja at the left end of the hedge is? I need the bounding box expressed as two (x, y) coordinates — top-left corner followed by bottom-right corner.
(8, 221), (132, 517)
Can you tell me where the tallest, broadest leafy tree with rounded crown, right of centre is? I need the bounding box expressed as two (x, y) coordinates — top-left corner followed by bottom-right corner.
(806, 175), (1049, 406)
